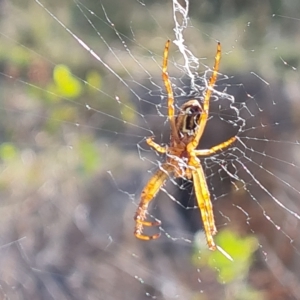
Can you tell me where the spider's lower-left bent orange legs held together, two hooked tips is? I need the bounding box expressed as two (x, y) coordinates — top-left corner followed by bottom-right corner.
(134, 163), (173, 241)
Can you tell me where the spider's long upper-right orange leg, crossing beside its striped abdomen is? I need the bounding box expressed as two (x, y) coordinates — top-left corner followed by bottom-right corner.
(187, 42), (221, 152)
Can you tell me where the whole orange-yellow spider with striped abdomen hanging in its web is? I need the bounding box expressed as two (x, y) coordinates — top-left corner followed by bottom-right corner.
(134, 40), (236, 250)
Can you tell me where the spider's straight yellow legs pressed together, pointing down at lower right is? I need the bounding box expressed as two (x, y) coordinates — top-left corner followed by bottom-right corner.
(190, 158), (217, 250)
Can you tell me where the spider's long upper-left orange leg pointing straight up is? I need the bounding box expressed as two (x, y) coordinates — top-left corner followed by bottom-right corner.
(162, 40), (179, 140)
